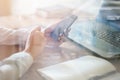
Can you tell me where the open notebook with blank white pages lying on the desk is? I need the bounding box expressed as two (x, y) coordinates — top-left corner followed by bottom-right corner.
(38, 56), (120, 80)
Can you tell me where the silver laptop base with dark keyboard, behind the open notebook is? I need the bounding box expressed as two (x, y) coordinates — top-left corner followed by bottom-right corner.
(68, 19), (120, 58)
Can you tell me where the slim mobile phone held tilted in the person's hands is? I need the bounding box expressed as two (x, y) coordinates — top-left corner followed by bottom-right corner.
(50, 15), (77, 41)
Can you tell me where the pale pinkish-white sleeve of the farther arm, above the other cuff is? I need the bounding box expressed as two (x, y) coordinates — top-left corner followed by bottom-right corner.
(0, 27), (29, 45)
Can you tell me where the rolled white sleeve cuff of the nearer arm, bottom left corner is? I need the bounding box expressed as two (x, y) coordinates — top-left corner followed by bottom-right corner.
(0, 52), (33, 80)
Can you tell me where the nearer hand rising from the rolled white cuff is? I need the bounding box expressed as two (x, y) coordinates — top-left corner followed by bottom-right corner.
(24, 27), (46, 58)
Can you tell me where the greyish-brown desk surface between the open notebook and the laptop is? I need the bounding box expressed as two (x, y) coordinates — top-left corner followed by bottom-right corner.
(21, 42), (120, 80)
